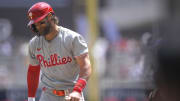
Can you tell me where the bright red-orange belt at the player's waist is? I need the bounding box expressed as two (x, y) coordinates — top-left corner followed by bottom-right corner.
(42, 87), (66, 96)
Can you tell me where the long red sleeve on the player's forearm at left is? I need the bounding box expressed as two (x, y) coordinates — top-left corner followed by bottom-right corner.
(27, 65), (40, 97)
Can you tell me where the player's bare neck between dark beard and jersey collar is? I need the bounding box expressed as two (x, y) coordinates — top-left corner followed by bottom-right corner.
(45, 25), (59, 41)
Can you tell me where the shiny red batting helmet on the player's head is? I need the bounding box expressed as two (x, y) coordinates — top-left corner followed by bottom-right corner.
(28, 2), (54, 26)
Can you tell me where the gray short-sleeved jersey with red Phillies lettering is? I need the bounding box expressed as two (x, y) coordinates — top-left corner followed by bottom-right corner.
(29, 26), (88, 90)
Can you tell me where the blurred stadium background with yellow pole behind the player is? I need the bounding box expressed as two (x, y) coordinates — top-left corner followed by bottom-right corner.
(0, 0), (180, 101)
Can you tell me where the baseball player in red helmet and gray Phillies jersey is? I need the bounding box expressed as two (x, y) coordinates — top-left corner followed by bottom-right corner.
(27, 2), (91, 101)
